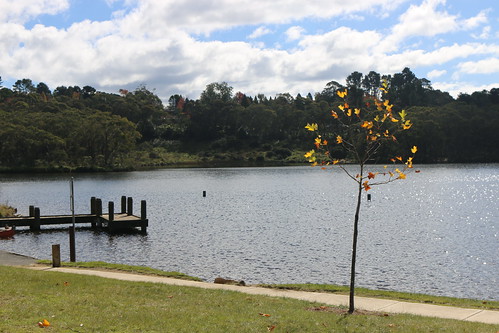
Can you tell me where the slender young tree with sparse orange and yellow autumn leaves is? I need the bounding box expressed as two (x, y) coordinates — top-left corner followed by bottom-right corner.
(305, 81), (417, 314)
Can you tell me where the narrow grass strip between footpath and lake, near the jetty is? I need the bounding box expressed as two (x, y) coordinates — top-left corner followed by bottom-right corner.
(37, 260), (202, 281)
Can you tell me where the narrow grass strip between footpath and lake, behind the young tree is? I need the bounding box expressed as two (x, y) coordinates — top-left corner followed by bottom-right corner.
(260, 284), (499, 310)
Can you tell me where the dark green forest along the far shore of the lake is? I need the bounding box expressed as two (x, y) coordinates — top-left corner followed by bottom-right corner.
(0, 68), (499, 171)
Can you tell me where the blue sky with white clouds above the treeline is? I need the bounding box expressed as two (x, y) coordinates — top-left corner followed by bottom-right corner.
(0, 0), (499, 101)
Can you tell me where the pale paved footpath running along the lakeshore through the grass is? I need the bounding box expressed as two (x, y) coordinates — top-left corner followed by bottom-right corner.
(0, 251), (499, 325)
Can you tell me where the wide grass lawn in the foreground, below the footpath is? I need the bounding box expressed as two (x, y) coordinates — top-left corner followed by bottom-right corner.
(0, 266), (497, 333)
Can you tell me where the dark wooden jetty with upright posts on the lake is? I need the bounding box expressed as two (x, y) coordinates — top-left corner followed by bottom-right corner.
(0, 196), (148, 232)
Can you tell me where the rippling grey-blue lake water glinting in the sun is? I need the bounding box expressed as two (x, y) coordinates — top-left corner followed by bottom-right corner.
(0, 164), (499, 300)
